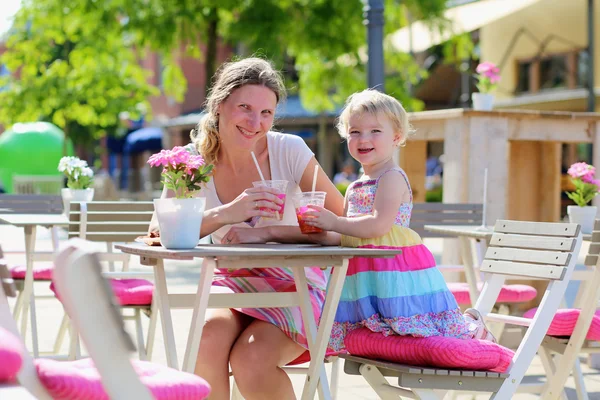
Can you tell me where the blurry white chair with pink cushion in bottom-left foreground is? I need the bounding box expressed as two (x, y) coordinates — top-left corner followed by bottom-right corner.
(0, 239), (210, 400)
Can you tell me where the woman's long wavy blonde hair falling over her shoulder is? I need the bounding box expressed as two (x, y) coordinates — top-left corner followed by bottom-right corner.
(190, 57), (286, 164)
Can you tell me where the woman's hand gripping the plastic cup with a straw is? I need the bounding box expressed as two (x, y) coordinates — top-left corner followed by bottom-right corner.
(221, 187), (284, 225)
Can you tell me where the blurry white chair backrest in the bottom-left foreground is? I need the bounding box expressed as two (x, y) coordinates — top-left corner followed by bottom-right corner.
(53, 239), (153, 399)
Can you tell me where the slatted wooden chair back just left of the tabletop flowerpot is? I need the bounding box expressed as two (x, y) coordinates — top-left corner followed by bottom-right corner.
(69, 201), (154, 242)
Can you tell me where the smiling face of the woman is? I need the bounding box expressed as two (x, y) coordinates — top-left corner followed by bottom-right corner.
(218, 85), (277, 148)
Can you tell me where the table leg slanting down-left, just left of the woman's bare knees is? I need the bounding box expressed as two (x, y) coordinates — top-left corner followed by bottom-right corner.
(183, 257), (217, 373)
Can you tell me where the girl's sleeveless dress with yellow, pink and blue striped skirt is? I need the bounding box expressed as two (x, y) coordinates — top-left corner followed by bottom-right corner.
(329, 168), (470, 352)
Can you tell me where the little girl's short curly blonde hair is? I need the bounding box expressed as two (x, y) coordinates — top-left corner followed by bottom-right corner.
(336, 89), (414, 146)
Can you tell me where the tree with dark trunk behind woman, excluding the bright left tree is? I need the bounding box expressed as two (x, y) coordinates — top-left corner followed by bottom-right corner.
(26, 0), (446, 112)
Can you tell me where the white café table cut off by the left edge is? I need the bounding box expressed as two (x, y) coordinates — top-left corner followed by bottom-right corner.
(0, 213), (69, 357)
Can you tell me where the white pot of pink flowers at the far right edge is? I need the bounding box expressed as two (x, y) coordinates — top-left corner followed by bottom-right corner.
(565, 162), (600, 233)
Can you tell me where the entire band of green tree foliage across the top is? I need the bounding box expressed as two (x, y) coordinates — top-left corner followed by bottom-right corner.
(0, 0), (446, 150)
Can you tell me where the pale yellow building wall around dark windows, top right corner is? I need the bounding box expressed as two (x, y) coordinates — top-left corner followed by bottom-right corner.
(480, 0), (600, 111)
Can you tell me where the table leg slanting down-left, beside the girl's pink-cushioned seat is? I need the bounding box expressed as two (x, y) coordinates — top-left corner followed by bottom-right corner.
(302, 259), (348, 399)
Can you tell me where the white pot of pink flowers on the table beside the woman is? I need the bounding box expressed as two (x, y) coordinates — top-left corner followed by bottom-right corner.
(148, 146), (213, 249)
